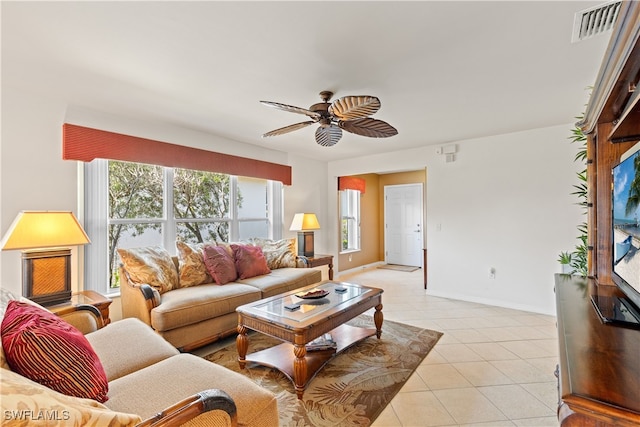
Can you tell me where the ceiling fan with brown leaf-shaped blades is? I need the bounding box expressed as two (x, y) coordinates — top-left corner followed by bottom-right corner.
(260, 90), (398, 147)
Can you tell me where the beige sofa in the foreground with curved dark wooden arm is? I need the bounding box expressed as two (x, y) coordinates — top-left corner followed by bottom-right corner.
(0, 290), (278, 427)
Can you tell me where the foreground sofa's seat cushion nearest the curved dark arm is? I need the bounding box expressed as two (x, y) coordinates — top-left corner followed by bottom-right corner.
(107, 352), (278, 426)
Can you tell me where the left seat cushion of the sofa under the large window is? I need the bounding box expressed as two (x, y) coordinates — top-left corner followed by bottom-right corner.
(151, 282), (261, 331)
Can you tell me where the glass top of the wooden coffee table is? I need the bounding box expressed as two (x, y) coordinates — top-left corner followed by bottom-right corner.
(254, 282), (372, 321)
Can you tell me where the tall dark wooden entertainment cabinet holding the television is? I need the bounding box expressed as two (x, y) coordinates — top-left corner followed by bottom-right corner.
(555, 1), (640, 426)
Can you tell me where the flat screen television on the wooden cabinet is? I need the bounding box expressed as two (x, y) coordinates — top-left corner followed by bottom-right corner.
(607, 142), (640, 325)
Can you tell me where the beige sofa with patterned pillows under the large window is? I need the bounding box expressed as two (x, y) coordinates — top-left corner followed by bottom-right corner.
(120, 239), (322, 351)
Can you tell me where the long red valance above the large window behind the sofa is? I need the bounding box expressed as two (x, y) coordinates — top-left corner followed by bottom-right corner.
(62, 123), (291, 185)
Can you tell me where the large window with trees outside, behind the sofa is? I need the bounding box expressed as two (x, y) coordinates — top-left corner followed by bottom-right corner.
(84, 160), (282, 294)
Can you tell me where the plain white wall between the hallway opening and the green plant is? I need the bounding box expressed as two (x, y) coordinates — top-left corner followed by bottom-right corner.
(327, 123), (584, 314)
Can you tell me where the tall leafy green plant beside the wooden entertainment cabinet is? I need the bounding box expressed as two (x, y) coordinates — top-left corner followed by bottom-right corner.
(558, 114), (588, 276)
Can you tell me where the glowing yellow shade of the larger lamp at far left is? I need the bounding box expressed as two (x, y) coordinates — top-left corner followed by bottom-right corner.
(0, 211), (90, 251)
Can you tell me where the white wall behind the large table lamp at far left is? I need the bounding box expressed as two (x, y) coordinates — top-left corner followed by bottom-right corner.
(0, 90), (77, 295)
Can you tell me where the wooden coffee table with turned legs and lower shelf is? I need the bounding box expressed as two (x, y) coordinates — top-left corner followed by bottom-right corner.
(236, 281), (383, 399)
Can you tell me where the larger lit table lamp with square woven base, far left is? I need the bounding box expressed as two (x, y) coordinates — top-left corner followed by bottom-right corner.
(0, 211), (90, 305)
